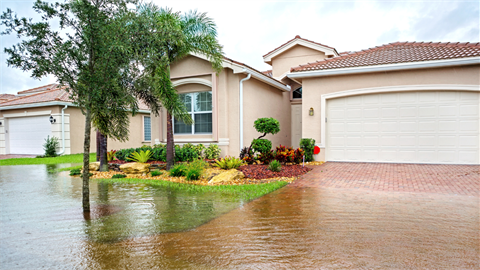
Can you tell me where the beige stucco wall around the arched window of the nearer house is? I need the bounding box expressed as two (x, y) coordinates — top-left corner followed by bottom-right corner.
(152, 57), (291, 156)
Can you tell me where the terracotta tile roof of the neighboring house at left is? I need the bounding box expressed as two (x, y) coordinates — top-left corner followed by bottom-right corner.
(0, 85), (150, 111)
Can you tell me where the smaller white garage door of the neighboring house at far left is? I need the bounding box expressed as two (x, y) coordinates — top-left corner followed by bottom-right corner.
(8, 116), (52, 155)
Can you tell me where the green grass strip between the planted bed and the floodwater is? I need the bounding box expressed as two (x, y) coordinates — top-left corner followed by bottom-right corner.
(95, 178), (288, 201)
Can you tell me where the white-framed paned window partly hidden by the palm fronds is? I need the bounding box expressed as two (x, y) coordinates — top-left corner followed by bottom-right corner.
(173, 92), (212, 134)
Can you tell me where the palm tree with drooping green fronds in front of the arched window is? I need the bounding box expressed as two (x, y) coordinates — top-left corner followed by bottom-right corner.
(132, 4), (223, 169)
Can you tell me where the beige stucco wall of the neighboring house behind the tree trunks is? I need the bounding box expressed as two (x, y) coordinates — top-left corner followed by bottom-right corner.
(65, 107), (150, 154)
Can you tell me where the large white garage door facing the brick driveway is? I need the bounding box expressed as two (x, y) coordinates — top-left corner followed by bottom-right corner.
(326, 91), (480, 164)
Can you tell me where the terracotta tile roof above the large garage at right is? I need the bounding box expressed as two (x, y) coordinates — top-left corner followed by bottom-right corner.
(290, 42), (480, 72)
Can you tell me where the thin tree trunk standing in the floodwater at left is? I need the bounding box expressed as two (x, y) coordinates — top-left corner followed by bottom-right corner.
(82, 108), (92, 213)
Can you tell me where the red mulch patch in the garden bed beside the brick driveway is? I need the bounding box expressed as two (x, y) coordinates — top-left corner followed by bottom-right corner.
(238, 165), (312, 179)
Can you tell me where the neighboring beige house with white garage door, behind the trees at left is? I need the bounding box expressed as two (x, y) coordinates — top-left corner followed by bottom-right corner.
(0, 84), (151, 155)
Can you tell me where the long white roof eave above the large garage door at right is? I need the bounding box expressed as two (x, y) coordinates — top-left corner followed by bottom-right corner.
(287, 56), (480, 79)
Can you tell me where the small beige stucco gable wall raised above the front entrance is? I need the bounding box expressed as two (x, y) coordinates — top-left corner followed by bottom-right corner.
(272, 45), (326, 77)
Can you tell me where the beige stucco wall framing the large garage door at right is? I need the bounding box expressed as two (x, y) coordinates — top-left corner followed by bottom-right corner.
(302, 65), (480, 160)
